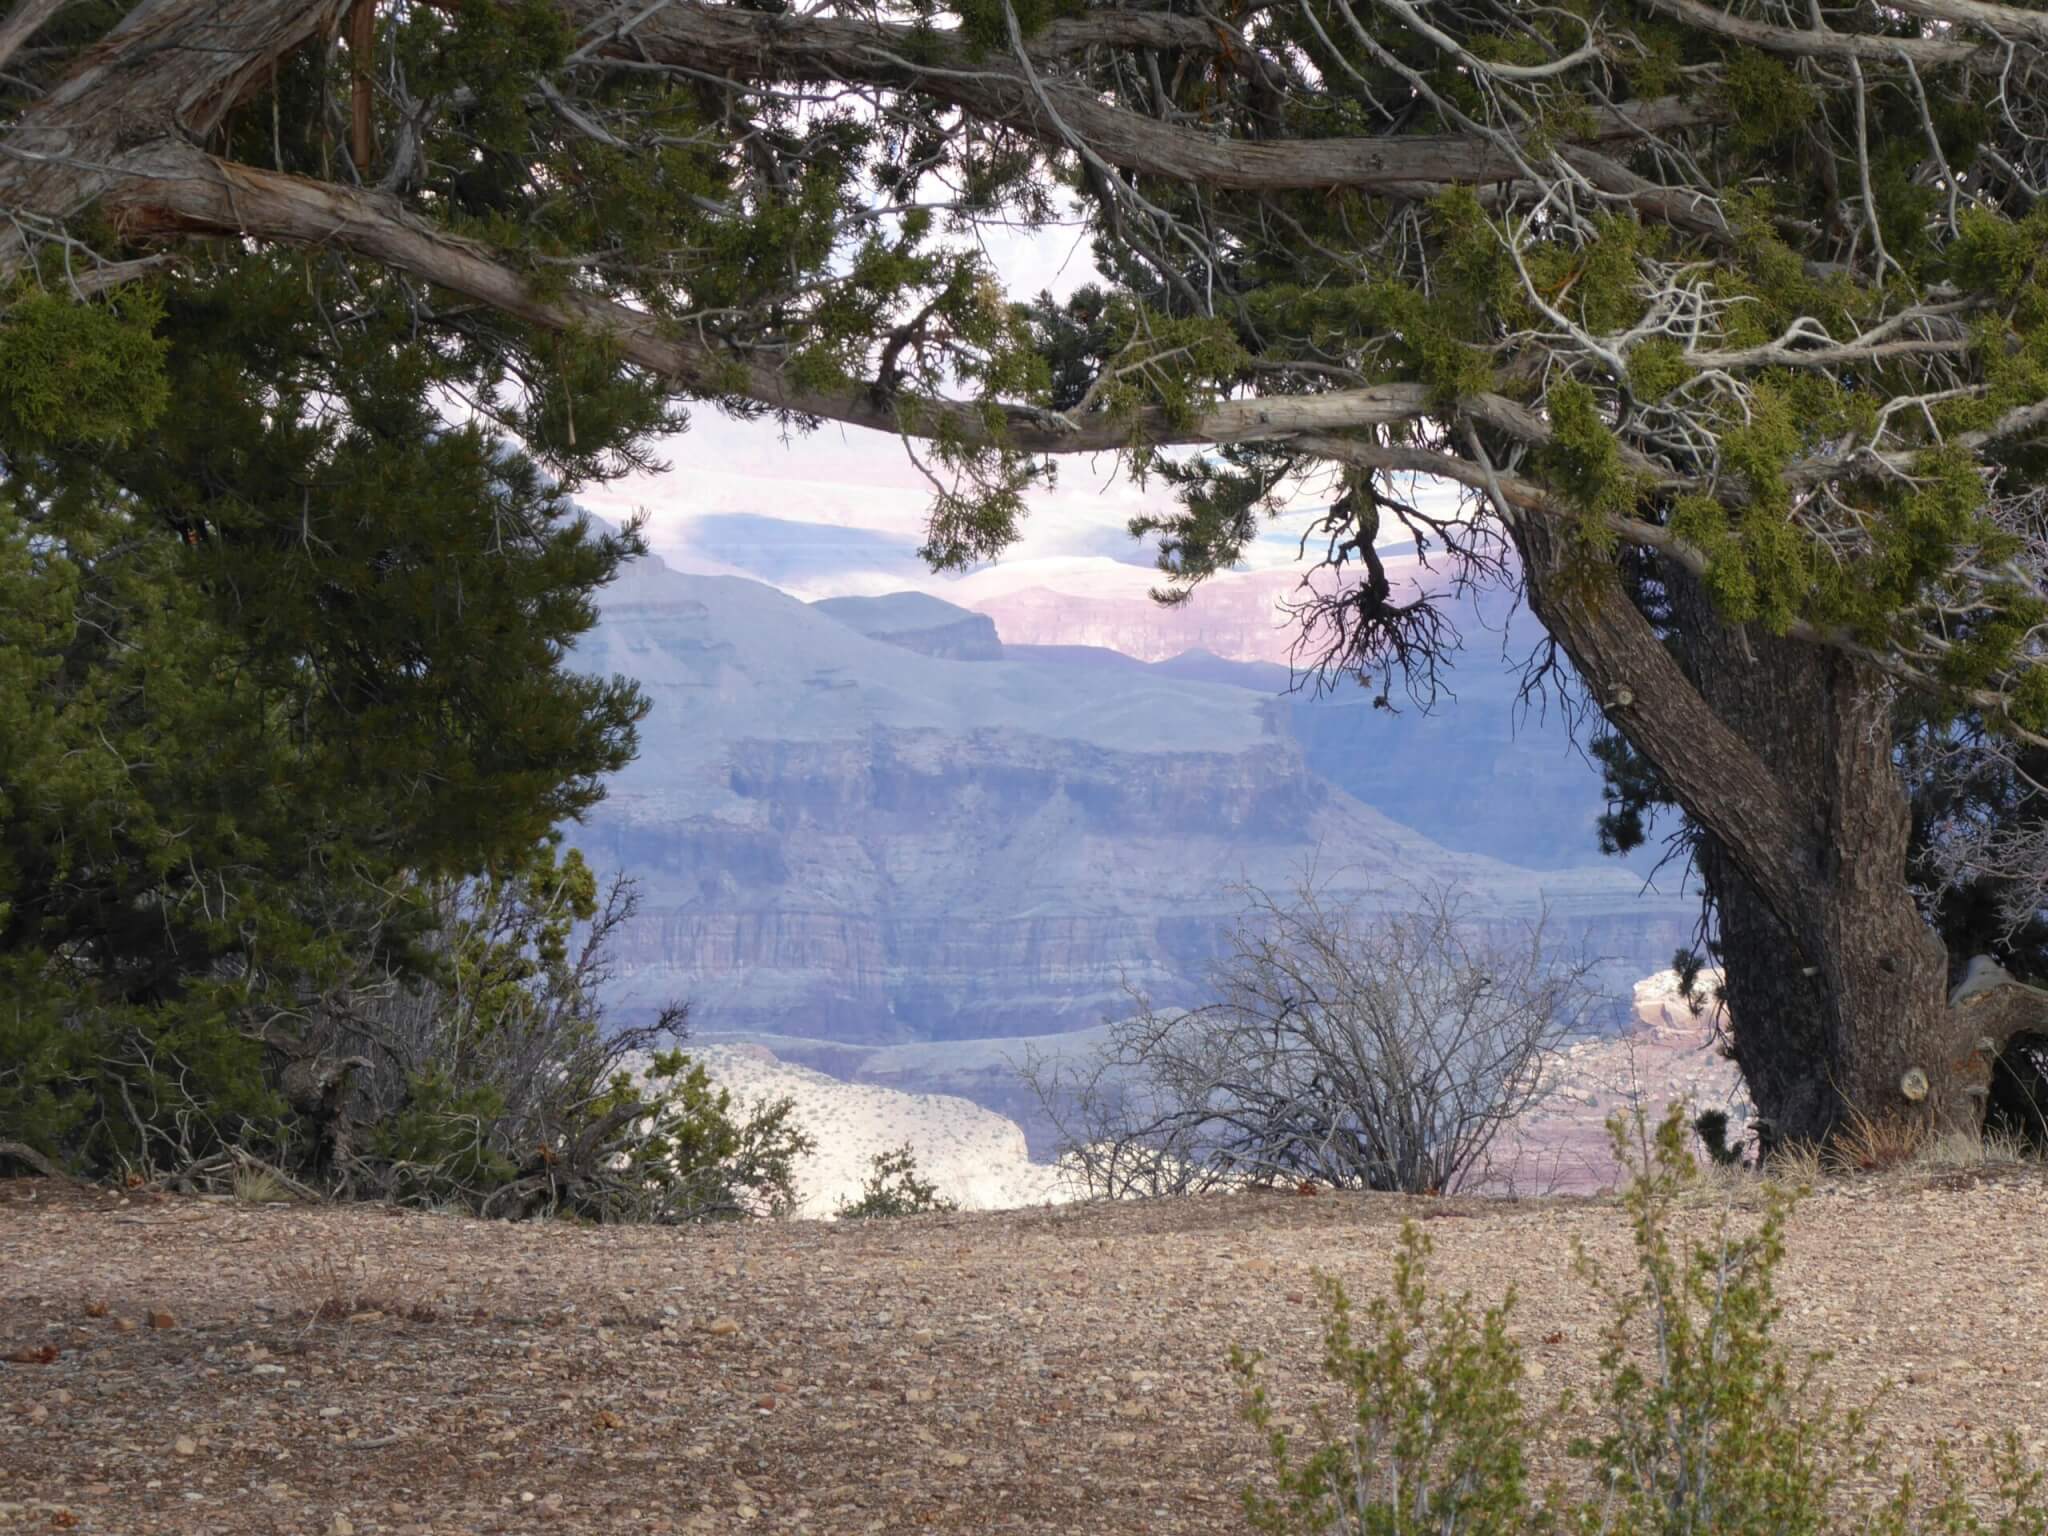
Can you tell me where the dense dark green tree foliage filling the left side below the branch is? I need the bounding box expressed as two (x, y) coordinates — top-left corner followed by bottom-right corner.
(0, 204), (659, 1174)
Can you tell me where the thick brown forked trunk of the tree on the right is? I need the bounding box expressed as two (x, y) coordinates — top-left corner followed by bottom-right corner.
(1516, 518), (2032, 1145)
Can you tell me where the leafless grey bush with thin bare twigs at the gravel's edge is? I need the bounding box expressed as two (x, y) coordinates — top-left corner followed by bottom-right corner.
(1024, 881), (1595, 1198)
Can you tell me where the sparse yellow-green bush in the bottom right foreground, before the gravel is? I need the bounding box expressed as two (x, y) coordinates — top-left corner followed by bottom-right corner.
(1231, 1106), (2048, 1536)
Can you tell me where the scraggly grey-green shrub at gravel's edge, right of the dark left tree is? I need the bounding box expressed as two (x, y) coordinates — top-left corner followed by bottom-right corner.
(290, 838), (815, 1221)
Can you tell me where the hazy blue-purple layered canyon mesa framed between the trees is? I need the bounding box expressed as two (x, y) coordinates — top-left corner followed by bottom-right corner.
(571, 559), (1694, 1051)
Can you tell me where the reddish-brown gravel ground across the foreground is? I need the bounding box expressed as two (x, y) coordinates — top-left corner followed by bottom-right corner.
(0, 1167), (2048, 1536)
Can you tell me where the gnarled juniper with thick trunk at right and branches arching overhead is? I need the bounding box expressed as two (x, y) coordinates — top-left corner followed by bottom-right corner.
(12, 0), (2048, 1135)
